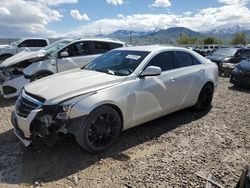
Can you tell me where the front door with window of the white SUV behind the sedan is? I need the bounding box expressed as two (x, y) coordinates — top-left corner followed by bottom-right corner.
(57, 41), (96, 72)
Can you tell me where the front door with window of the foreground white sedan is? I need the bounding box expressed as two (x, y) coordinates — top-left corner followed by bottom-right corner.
(133, 51), (179, 124)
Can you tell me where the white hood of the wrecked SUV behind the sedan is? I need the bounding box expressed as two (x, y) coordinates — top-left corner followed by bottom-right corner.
(0, 50), (46, 67)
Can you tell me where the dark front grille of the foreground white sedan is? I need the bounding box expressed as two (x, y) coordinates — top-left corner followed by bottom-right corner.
(16, 93), (42, 118)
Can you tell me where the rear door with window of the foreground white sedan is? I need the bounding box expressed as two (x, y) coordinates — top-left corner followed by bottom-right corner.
(171, 51), (204, 110)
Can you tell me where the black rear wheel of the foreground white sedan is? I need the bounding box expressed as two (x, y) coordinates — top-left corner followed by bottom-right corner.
(194, 83), (214, 111)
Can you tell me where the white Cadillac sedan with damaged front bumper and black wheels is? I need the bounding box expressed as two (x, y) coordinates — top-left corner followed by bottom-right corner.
(12, 45), (218, 153)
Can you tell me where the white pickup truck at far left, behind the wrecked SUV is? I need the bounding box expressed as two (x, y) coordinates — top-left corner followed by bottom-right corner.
(0, 38), (49, 63)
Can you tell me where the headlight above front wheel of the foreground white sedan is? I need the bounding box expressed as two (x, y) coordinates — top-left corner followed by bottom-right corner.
(57, 92), (97, 120)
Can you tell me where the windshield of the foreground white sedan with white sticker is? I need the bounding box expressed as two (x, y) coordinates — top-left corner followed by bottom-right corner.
(84, 50), (149, 76)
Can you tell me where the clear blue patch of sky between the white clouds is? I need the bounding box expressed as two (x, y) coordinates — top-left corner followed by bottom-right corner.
(49, 0), (220, 31)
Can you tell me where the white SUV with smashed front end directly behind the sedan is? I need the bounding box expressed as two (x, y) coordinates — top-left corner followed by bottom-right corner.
(0, 38), (125, 98)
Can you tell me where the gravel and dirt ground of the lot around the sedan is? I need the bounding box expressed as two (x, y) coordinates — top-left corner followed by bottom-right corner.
(0, 78), (250, 188)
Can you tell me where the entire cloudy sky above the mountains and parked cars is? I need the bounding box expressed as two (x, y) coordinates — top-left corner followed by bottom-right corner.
(0, 0), (250, 37)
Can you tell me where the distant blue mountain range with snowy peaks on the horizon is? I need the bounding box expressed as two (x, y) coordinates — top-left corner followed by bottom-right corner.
(105, 25), (250, 44)
